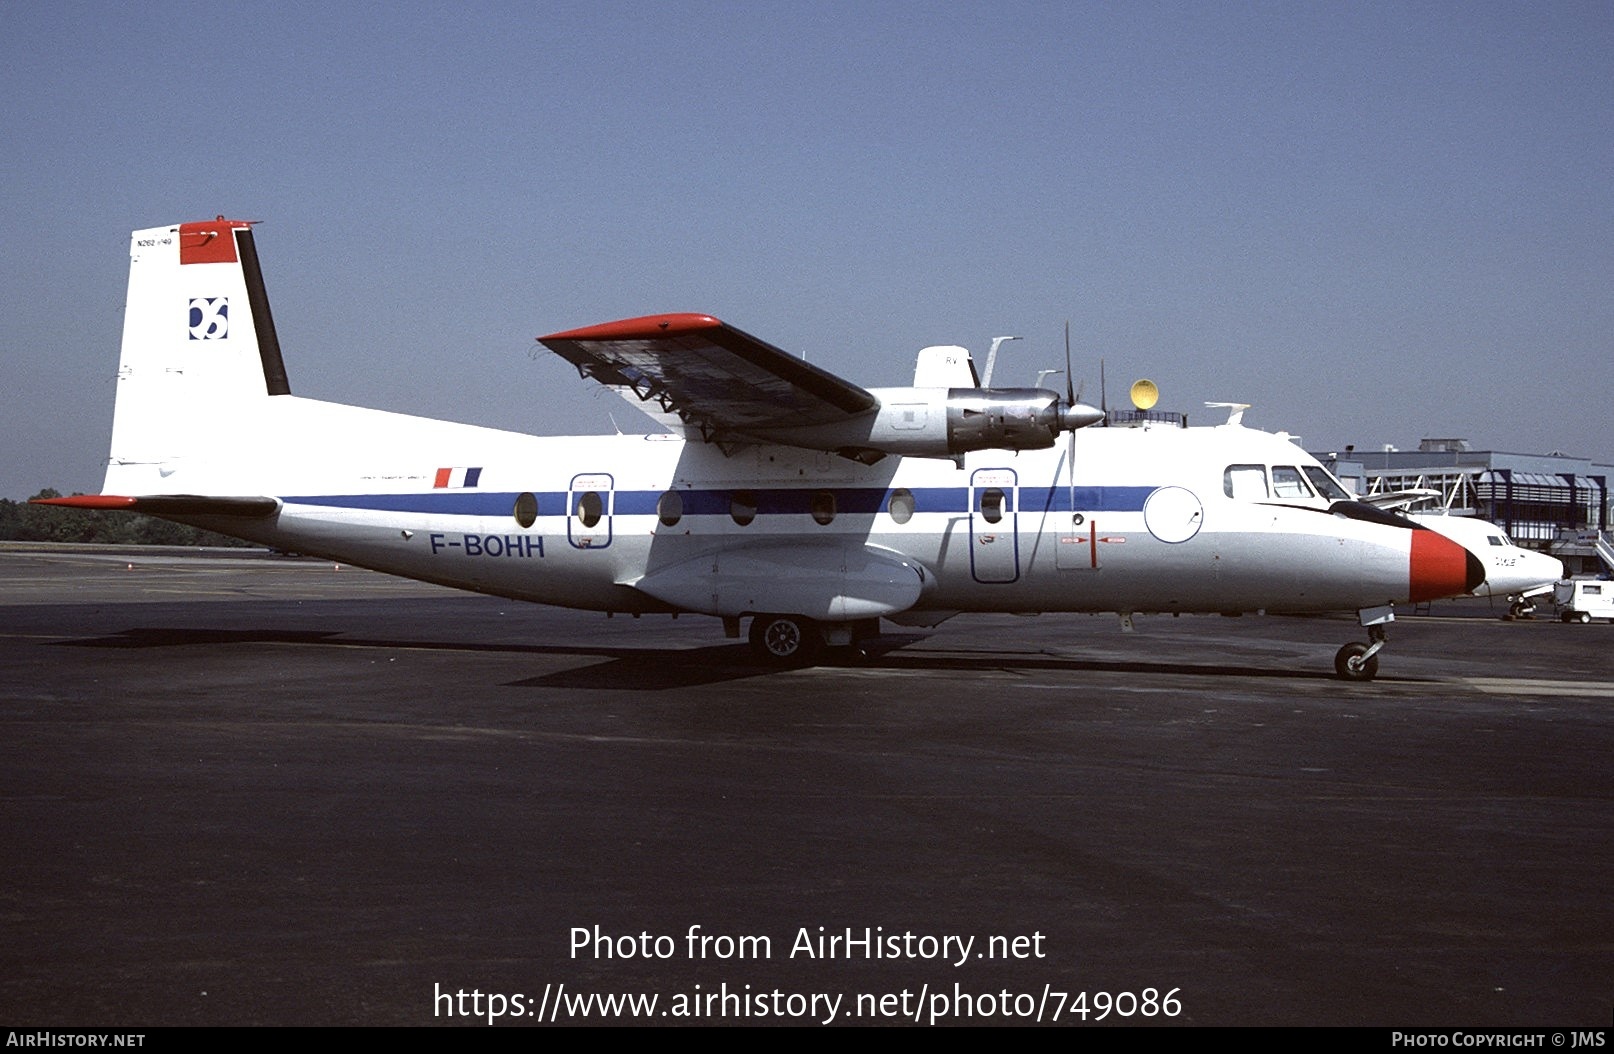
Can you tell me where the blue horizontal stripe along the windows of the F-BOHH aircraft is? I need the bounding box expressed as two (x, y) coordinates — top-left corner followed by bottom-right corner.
(281, 486), (1156, 517)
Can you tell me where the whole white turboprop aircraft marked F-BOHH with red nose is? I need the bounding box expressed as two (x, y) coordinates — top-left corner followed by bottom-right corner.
(34, 218), (1536, 680)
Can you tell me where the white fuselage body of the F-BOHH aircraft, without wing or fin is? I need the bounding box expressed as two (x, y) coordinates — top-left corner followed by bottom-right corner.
(165, 397), (1462, 620)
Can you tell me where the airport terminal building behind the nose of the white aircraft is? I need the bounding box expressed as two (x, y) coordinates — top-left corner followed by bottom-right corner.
(1314, 439), (1614, 575)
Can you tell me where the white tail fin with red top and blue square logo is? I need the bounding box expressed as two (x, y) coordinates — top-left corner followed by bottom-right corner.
(102, 216), (291, 494)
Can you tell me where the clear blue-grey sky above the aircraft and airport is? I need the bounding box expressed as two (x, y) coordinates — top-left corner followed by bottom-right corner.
(0, 0), (1614, 499)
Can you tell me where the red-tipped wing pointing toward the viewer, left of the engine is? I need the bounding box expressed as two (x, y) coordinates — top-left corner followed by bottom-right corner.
(539, 315), (880, 442)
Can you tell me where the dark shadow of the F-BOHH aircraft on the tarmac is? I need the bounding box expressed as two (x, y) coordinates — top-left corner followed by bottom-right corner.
(56, 626), (1355, 691)
